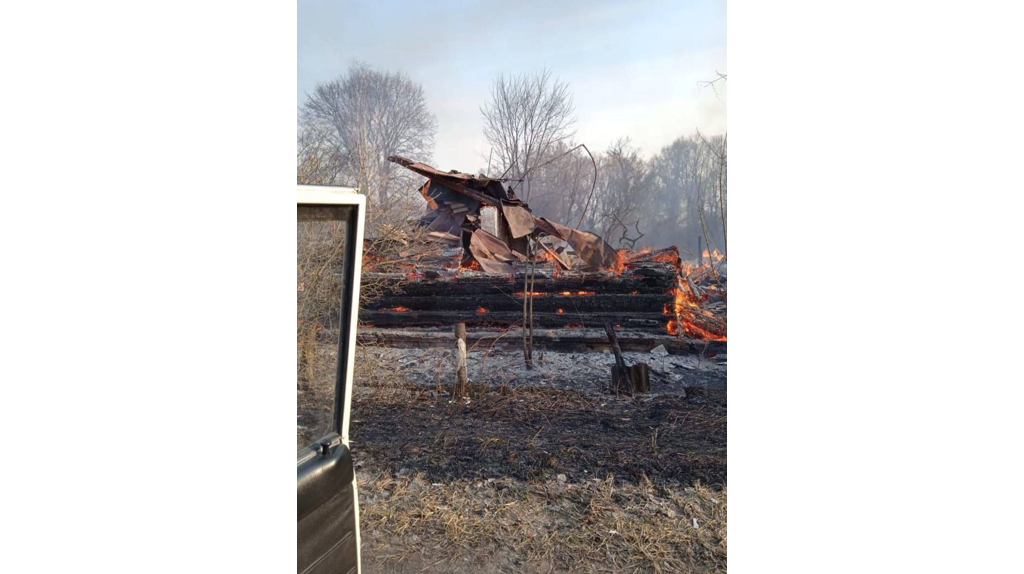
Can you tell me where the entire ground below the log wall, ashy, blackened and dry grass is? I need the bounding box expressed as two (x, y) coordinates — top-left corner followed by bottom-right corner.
(351, 347), (727, 573)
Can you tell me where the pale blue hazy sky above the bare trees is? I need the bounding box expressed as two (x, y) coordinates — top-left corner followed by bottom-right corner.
(298, 0), (728, 172)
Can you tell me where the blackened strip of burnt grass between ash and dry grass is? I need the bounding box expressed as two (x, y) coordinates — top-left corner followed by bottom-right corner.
(351, 387), (727, 488)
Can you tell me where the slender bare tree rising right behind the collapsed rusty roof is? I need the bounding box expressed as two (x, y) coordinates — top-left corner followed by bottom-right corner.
(480, 70), (575, 201)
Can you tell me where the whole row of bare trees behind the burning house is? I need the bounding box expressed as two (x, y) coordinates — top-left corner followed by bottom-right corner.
(297, 64), (728, 256)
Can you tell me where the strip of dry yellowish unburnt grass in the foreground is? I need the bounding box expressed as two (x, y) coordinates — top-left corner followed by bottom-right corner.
(359, 473), (727, 572)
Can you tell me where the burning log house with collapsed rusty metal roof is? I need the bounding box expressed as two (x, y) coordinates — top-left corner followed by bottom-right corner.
(360, 157), (726, 347)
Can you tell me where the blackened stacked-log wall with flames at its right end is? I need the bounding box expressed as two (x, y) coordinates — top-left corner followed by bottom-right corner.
(360, 248), (726, 340)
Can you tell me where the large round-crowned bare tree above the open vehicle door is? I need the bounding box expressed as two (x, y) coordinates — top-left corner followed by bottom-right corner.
(300, 63), (437, 230)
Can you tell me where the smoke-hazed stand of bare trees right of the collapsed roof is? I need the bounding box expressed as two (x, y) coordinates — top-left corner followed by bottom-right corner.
(520, 132), (728, 256)
